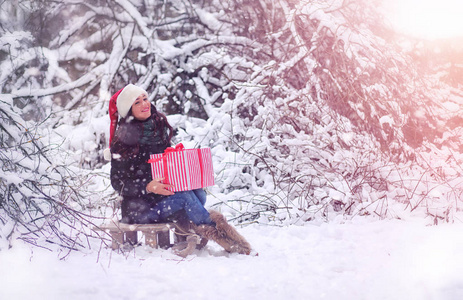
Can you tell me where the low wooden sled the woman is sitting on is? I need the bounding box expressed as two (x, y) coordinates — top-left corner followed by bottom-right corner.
(95, 221), (177, 250)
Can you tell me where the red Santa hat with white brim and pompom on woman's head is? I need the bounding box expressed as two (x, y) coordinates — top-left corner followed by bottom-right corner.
(103, 84), (148, 160)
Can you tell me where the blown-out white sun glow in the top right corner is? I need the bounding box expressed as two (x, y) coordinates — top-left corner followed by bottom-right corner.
(385, 0), (463, 39)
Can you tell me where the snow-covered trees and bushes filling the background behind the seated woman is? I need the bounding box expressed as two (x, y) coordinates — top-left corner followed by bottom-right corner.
(0, 0), (463, 255)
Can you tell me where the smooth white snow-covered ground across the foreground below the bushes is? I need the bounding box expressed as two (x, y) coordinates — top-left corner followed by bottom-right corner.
(0, 218), (463, 300)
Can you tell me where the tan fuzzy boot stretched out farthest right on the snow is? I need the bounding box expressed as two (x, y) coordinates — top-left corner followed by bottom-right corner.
(194, 211), (251, 255)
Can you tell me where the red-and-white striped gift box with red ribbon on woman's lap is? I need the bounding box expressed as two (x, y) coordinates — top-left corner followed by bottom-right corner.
(148, 144), (214, 192)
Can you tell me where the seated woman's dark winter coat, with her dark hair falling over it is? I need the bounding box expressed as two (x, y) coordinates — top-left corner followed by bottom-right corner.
(111, 106), (172, 223)
